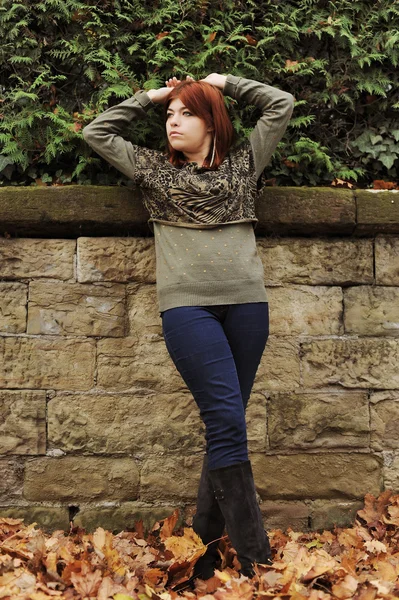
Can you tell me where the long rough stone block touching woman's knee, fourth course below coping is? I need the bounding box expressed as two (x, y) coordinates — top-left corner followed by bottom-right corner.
(48, 392), (204, 454)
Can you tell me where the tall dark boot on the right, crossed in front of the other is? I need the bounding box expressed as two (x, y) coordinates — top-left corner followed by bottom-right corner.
(209, 460), (272, 577)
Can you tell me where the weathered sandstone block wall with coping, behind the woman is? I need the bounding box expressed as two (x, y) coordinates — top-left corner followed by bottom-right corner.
(0, 186), (399, 531)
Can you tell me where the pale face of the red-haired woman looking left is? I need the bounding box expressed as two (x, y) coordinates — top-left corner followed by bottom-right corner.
(166, 98), (212, 154)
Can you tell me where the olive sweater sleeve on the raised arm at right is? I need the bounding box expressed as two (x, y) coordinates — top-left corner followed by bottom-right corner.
(223, 75), (294, 179)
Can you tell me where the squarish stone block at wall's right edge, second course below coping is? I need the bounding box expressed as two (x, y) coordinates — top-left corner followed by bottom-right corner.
(344, 286), (399, 337)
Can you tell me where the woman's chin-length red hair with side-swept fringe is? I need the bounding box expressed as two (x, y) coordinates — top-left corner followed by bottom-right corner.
(164, 81), (234, 170)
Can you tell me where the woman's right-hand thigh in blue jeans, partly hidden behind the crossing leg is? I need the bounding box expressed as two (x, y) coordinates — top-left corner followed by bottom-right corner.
(223, 302), (269, 409)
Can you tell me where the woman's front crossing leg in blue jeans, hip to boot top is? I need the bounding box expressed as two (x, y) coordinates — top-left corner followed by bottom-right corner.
(162, 306), (247, 468)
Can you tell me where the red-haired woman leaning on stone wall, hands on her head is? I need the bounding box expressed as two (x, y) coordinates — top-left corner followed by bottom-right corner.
(83, 73), (294, 579)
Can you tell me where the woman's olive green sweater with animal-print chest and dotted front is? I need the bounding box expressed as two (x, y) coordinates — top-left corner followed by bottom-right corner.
(83, 75), (294, 312)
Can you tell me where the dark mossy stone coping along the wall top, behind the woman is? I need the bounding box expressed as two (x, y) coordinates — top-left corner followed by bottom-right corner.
(0, 185), (399, 238)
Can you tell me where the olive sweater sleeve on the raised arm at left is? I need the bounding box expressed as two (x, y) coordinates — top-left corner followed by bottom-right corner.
(82, 90), (163, 183)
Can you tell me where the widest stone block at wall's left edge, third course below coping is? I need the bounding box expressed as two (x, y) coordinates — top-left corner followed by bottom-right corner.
(0, 336), (95, 390)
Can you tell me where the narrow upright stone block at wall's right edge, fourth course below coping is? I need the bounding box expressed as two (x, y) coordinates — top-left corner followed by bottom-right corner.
(370, 390), (399, 450)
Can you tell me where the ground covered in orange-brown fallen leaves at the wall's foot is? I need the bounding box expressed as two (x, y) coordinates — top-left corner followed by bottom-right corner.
(0, 491), (399, 600)
